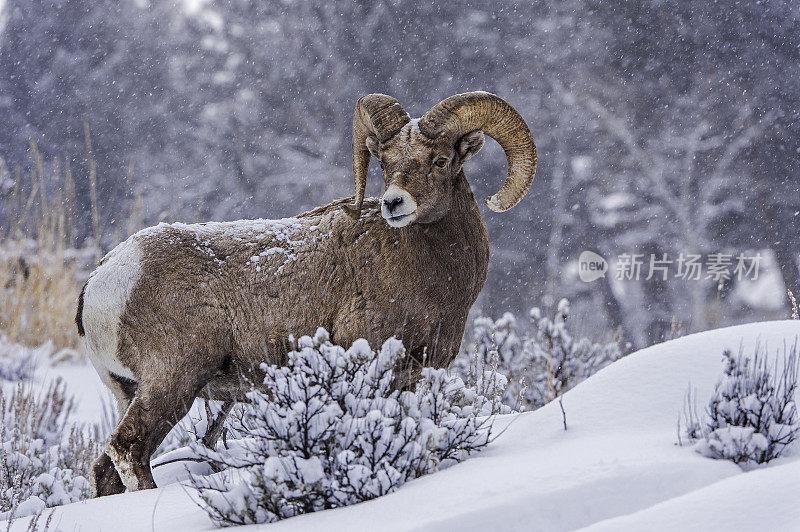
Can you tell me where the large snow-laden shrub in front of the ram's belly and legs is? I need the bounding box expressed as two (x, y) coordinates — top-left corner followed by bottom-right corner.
(192, 329), (494, 524)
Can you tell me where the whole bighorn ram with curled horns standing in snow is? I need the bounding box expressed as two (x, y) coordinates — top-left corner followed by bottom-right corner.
(76, 92), (536, 495)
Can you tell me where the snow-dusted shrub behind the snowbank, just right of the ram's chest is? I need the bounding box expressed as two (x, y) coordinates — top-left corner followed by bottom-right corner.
(453, 299), (622, 408)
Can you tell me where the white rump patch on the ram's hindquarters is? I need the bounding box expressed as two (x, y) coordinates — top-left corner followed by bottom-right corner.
(82, 238), (142, 386)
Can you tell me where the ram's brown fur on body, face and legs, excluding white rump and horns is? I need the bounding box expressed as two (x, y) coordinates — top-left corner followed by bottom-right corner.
(89, 119), (500, 495)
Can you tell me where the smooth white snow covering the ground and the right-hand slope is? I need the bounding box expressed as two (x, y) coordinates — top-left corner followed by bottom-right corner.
(1, 321), (800, 532)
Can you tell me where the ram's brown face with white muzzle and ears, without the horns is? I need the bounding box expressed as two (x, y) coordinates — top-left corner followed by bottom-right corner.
(367, 121), (483, 227)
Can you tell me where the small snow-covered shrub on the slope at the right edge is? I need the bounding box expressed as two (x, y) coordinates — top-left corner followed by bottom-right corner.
(685, 344), (800, 464)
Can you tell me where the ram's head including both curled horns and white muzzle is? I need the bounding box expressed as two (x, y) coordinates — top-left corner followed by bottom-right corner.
(348, 92), (536, 227)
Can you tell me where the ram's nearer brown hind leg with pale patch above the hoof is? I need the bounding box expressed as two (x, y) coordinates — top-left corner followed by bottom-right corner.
(106, 368), (207, 491)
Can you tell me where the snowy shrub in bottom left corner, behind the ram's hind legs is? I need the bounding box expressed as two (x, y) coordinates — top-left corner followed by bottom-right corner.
(0, 380), (100, 519)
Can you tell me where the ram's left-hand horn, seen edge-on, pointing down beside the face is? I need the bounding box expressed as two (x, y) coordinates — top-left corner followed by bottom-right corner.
(345, 94), (411, 217)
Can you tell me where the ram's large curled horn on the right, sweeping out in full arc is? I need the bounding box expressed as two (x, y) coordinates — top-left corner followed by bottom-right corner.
(419, 92), (536, 212)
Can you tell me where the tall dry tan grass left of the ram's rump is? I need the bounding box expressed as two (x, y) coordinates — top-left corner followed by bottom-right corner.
(0, 132), (140, 358)
